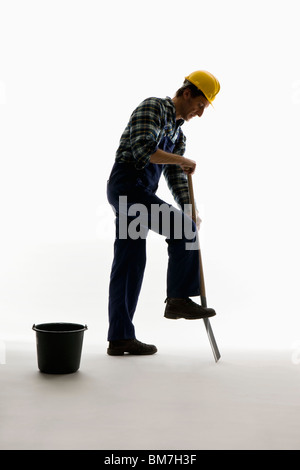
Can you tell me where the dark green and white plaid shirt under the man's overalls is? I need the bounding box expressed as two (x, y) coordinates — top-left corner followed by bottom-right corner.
(116, 97), (189, 208)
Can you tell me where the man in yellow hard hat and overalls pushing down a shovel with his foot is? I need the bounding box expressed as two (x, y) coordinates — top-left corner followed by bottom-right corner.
(107, 71), (220, 355)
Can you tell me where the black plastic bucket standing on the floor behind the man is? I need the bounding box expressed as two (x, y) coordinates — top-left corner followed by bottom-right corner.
(32, 323), (87, 374)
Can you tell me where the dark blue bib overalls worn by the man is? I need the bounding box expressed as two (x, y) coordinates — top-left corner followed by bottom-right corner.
(107, 137), (200, 341)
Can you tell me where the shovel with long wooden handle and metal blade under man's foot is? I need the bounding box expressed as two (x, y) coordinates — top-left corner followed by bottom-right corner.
(187, 174), (221, 362)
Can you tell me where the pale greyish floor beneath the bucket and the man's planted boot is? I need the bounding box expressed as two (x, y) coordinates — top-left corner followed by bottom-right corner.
(0, 342), (300, 450)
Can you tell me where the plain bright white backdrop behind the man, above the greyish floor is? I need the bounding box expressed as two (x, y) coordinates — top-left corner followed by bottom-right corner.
(0, 0), (300, 348)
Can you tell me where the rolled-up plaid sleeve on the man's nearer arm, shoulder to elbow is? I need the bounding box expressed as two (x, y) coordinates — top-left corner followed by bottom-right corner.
(130, 98), (164, 170)
